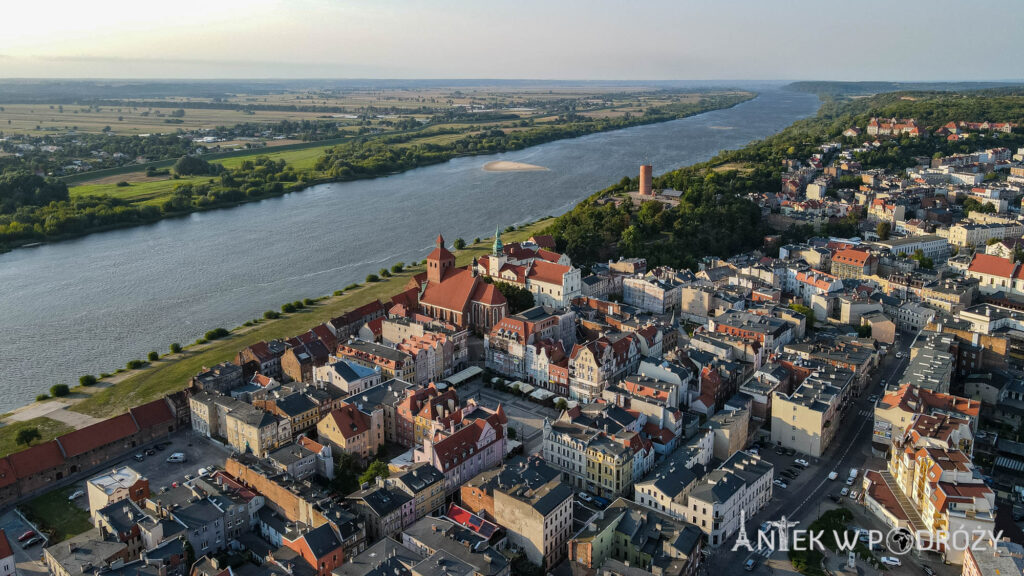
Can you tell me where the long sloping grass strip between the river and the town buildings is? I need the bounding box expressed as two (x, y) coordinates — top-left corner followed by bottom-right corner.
(71, 219), (550, 418)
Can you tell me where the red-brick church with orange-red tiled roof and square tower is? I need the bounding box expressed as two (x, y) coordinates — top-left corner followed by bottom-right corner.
(411, 235), (508, 332)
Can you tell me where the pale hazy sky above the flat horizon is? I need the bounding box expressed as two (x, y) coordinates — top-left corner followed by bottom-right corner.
(0, 0), (1024, 81)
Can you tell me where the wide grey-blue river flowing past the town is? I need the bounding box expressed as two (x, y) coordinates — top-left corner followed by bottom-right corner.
(0, 86), (818, 412)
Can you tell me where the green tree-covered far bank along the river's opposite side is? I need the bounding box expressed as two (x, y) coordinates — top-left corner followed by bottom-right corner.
(0, 91), (758, 252)
